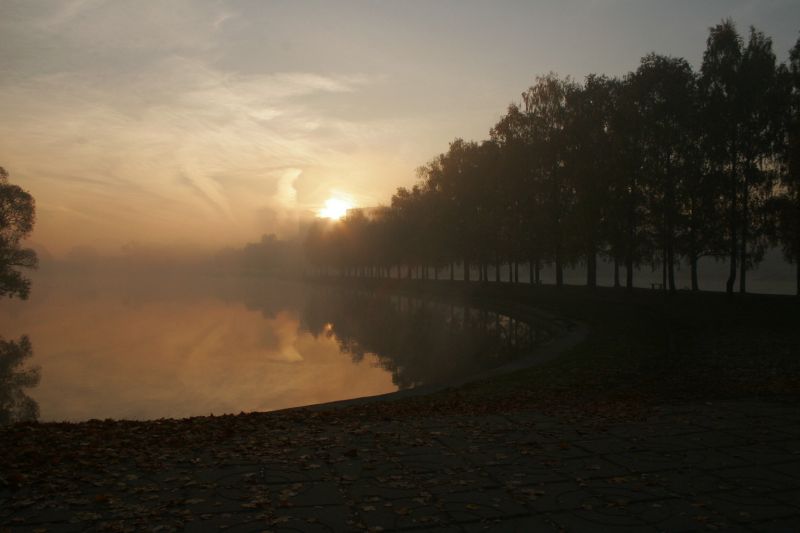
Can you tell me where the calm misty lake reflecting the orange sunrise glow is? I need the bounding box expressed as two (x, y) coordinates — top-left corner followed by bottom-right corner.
(0, 276), (543, 421)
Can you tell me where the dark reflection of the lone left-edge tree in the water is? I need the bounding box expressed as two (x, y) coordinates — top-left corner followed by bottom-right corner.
(0, 335), (40, 425)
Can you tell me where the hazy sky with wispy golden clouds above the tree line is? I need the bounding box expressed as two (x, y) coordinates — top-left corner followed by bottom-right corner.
(0, 0), (800, 255)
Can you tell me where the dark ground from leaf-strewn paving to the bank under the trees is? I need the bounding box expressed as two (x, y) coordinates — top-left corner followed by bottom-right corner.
(0, 284), (800, 531)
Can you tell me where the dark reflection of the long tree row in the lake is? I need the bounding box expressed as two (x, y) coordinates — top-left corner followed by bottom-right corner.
(303, 289), (548, 389)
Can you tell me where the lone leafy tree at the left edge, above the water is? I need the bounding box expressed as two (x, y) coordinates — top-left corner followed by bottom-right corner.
(0, 167), (38, 300)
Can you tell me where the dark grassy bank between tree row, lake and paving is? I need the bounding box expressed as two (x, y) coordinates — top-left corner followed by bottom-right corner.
(304, 279), (800, 416)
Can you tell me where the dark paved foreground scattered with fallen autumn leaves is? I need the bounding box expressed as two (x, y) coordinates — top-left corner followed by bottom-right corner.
(0, 401), (800, 532)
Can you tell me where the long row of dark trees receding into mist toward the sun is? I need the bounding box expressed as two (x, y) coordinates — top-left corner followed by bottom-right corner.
(306, 20), (800, 294)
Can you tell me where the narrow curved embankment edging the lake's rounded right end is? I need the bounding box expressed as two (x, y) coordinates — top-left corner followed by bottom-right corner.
(296, 280), (589, 411)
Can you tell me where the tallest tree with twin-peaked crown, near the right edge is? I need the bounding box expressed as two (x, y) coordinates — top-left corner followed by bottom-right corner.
(700, 20), (781, 294)
